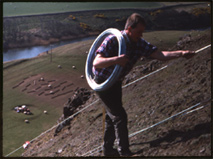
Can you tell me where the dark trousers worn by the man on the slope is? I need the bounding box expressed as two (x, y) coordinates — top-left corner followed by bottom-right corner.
(97, 81), (129, 151)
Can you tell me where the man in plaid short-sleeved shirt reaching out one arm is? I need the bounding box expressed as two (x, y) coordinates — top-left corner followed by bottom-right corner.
(93, 13), (195, 156)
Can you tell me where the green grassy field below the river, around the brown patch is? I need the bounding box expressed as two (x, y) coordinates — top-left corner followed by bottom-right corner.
(3, 31), (210, 156)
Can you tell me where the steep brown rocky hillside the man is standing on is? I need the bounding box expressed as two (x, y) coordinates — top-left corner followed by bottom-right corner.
(22, 29), (211, 157)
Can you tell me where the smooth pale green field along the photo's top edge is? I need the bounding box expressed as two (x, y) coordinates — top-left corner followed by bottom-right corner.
(3, 2), (161, 16)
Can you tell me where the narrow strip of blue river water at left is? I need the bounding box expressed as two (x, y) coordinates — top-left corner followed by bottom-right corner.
(3, 36), (95, 62)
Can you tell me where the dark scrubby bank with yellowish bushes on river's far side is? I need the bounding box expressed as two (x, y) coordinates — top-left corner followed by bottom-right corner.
(3, 3), (211, 50)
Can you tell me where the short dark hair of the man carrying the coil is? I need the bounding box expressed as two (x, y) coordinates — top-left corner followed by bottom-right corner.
(124, 13), (146, 30)
